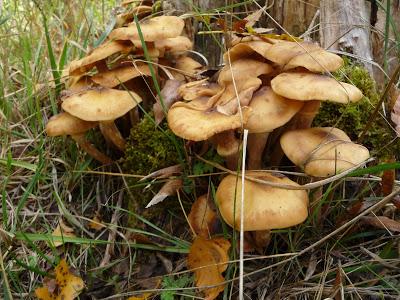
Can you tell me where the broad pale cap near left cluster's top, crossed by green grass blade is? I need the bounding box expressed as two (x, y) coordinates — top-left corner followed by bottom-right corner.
(109, 16), (185, 42)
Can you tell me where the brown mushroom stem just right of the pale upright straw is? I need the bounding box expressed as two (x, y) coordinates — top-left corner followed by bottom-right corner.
(247, 132), (269, 170)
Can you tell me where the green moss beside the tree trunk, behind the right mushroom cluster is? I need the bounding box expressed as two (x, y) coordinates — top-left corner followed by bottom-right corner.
(313, 59), (400, 159)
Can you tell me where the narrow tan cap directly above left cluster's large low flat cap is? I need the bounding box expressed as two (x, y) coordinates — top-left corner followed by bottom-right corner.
(92, 63), (151, 88)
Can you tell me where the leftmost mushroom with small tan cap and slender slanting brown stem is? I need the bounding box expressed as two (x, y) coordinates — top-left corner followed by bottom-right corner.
(45, 112), (112, 164)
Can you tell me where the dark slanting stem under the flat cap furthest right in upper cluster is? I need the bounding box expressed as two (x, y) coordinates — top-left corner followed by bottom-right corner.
(270, 100), (321, 166)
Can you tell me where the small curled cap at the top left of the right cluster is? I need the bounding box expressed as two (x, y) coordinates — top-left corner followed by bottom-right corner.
(224, 41), (271, 62)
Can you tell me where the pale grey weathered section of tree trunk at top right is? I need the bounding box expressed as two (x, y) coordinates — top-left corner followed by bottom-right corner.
(320, 0), (373, 74)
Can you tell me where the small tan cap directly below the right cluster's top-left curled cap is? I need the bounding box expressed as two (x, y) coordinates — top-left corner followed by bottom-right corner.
(218, 58), (273, 85)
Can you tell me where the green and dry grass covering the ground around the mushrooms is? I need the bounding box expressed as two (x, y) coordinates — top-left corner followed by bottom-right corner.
(0, 0), (400, 299)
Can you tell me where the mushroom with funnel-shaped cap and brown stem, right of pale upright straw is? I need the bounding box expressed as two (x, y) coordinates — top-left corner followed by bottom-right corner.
(244, 86), (303, 170)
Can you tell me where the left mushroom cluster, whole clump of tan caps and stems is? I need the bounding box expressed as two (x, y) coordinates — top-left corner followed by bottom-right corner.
(46, 1), (201, 164)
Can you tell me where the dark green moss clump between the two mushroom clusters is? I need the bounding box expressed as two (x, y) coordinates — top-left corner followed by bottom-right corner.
(122, 117), (179, 212)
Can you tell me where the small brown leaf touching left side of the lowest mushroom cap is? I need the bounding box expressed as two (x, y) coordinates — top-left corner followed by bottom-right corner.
(188, 194), (218, 237)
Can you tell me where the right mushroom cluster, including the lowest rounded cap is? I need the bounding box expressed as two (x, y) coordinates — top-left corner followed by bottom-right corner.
(168, 36), (369, 230)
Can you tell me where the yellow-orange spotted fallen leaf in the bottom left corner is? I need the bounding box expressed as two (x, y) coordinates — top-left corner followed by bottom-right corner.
(35, 259), (85, 300)
